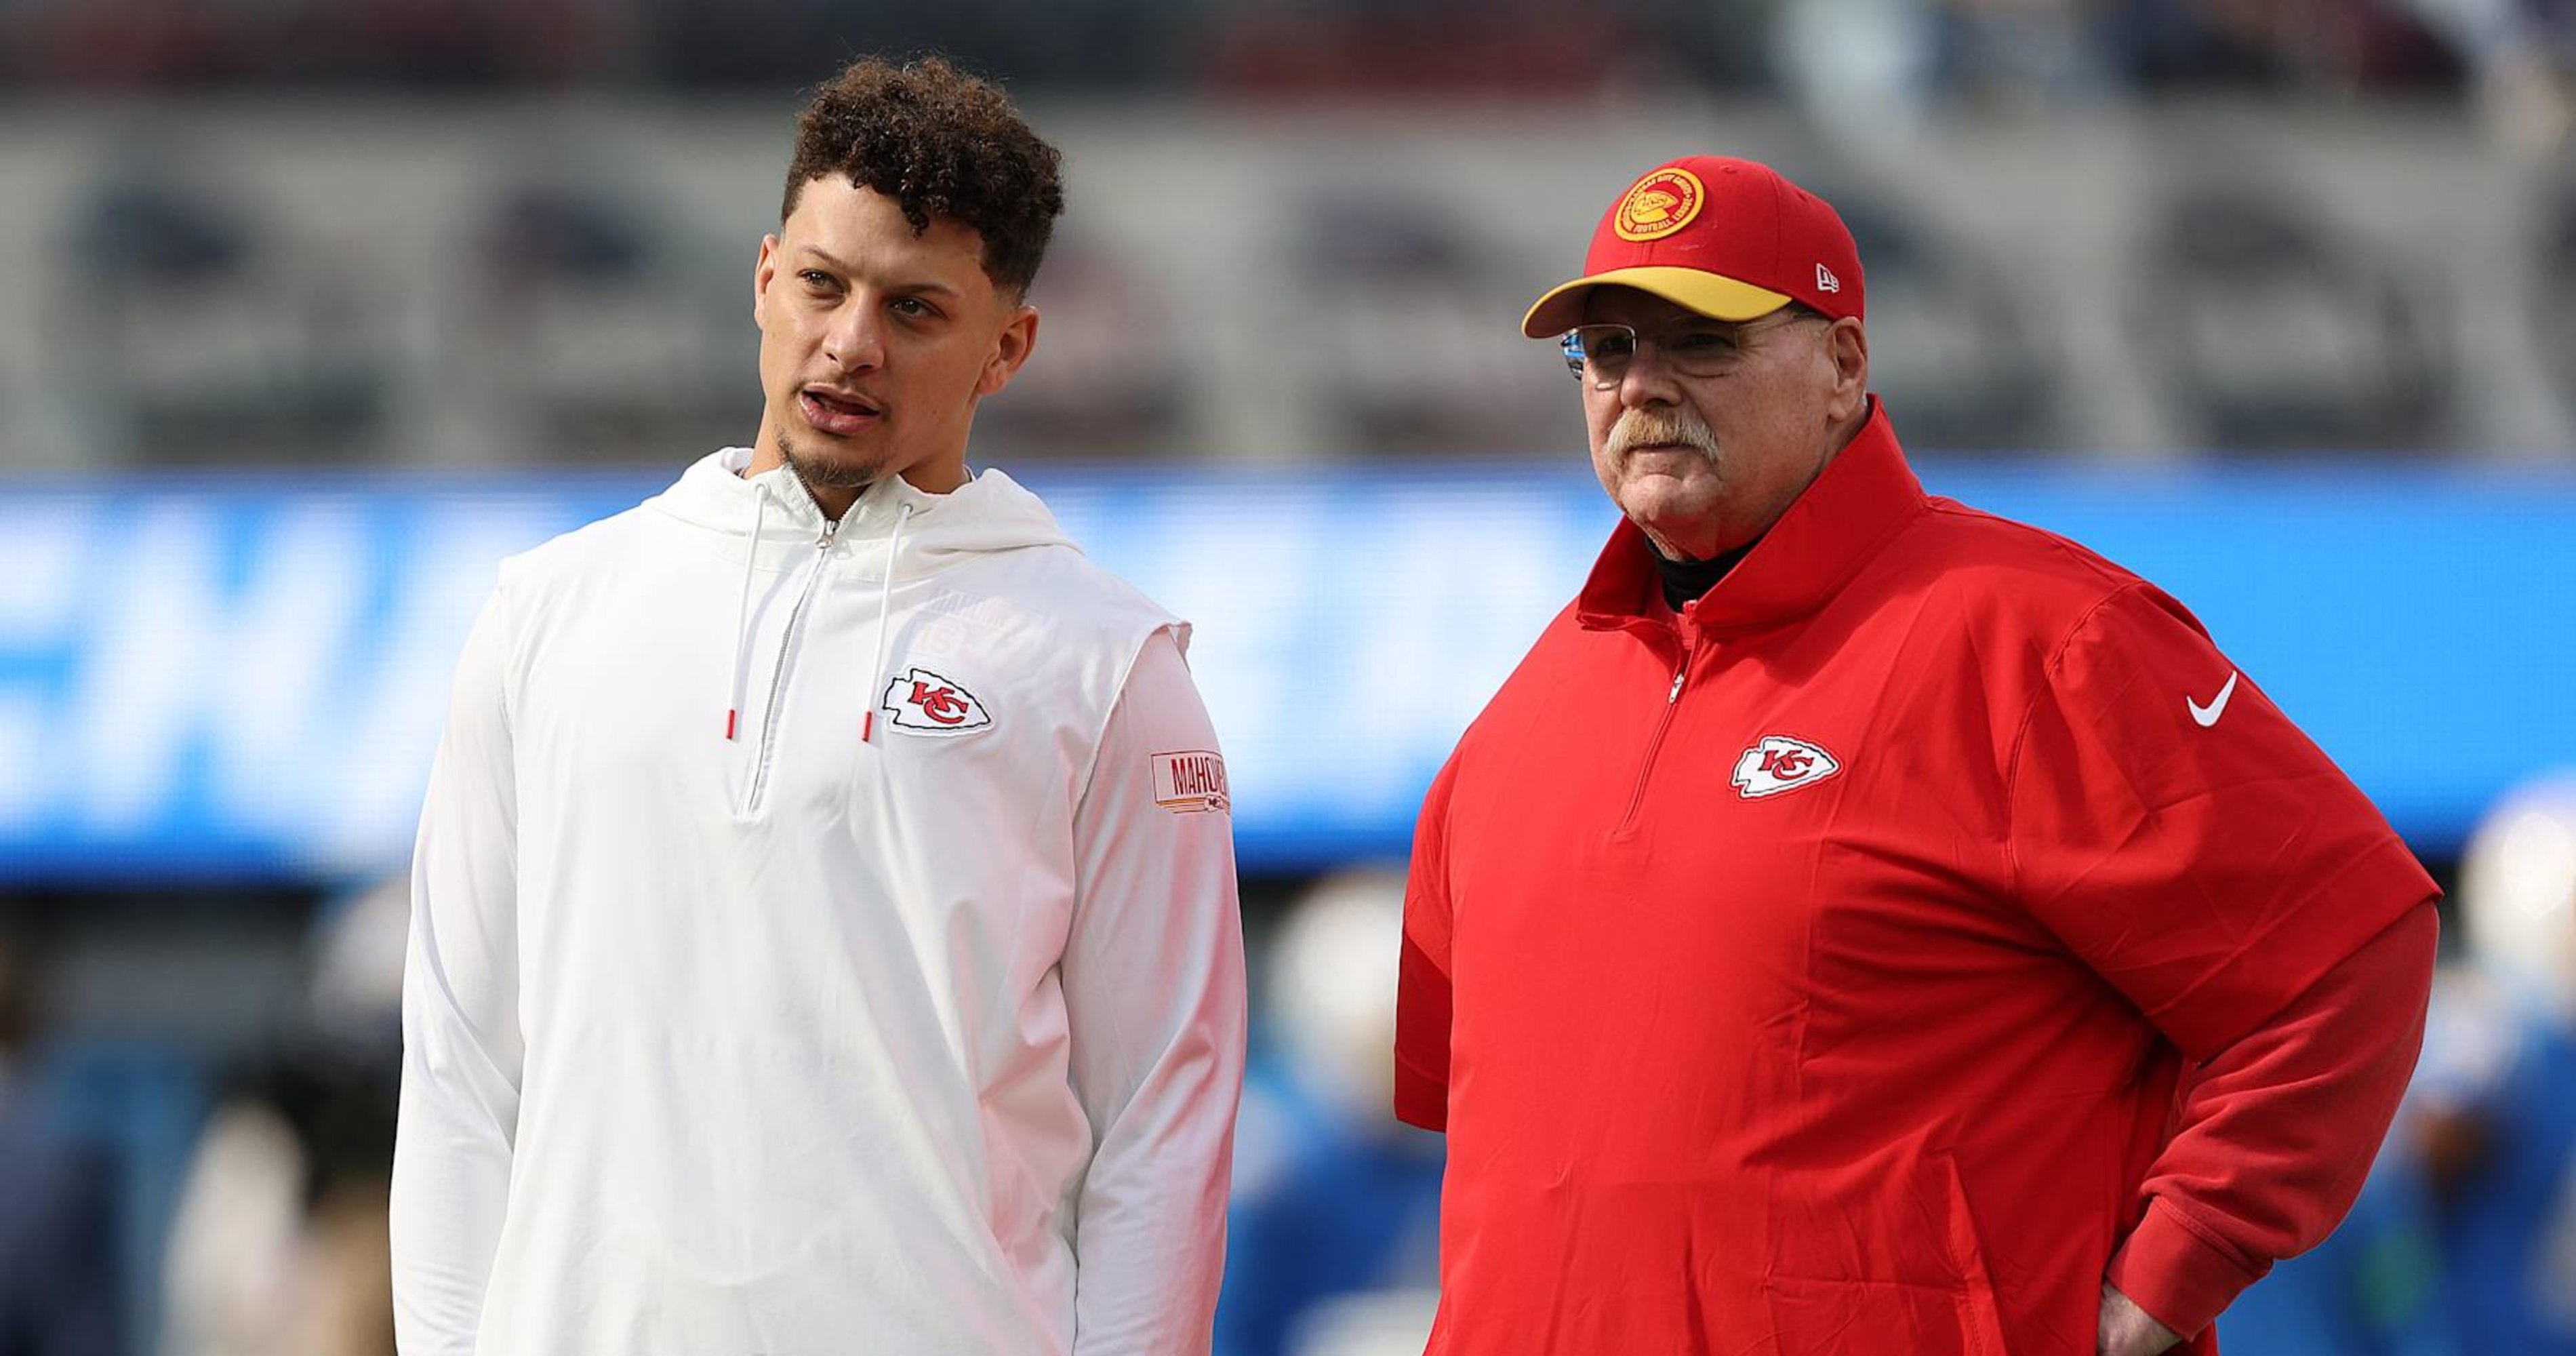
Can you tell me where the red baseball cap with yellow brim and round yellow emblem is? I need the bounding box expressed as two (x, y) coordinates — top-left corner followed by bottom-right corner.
(1520, 155), (1862, 338)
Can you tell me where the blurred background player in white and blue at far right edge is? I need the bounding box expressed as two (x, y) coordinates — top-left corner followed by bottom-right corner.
(2414, 771), (2576, 1356)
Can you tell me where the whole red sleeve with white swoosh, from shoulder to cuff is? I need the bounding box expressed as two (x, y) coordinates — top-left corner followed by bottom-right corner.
(2009, 585), (2440, 1333)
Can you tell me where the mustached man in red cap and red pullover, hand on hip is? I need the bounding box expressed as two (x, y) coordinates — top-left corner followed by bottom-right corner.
(1394, 155), (2437, 1356)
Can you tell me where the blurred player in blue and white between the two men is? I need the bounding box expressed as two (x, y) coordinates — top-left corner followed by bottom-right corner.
(1216, 869), (1440, 1356)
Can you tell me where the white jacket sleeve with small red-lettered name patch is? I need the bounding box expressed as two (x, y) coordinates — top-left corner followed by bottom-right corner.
(1064, 629), (1244, 1356)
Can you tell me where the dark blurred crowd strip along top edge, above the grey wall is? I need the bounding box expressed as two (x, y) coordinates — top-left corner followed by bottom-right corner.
(0, 0), (2576, 103)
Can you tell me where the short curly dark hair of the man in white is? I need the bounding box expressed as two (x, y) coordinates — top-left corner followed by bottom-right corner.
(778, 57), (1064, 296)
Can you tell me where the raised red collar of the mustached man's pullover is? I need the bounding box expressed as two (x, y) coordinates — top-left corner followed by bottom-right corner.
(1574, 399), (1925, 634)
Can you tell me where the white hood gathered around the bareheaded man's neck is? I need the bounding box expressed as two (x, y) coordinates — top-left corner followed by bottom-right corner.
(644, 449), (1074, 578)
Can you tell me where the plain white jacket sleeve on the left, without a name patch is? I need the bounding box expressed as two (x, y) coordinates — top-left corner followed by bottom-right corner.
(392, 593), (523, 1356)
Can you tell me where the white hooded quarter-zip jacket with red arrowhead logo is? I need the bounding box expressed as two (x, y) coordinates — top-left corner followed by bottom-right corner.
(392, 449), (1244, 1356)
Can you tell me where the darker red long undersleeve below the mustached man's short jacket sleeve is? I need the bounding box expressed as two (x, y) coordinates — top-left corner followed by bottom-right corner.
(2105, 900), (2437, 1336)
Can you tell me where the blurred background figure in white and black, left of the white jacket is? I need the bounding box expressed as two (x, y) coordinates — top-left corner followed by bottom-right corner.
(160, 877), (412, 1356)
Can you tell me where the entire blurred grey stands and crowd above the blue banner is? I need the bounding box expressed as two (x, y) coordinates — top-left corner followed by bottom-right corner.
(0, 0), (2576, 469)
